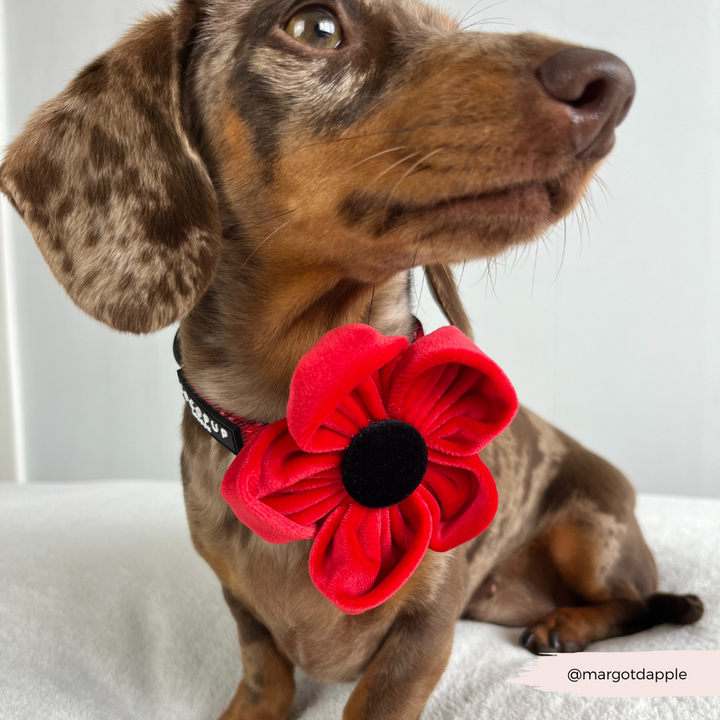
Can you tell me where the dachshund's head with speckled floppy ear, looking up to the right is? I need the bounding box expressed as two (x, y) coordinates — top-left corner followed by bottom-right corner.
(0, 0), (633, 332)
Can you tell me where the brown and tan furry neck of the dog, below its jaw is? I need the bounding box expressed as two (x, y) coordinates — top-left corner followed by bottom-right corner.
(181, 263), (415, 422)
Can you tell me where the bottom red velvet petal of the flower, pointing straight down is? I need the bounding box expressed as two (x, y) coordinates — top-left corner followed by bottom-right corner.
(310, 491), (433, 615)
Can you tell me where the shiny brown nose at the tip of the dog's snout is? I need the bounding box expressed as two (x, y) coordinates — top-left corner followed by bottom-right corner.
(537, 48), (635, 159)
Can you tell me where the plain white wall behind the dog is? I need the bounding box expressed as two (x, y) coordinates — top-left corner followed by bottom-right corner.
(0, 0), (720, 496)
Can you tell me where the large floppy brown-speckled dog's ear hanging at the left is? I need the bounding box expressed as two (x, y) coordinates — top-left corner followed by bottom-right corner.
(0, 0), (221, 333)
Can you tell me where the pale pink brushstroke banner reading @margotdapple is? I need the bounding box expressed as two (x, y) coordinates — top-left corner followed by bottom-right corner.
(507, 650), (720, 697)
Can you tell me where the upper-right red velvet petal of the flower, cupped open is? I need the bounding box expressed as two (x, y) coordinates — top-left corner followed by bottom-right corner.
(387, 327), (518, 457)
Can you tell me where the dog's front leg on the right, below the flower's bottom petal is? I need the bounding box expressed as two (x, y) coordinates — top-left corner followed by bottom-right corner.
(343, 557), (462, 720)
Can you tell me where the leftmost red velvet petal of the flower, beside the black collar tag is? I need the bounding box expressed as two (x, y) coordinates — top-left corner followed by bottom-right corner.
(221, 420), (347, 543)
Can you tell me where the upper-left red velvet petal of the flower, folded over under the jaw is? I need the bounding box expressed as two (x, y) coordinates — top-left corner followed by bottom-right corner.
(287, 325), (409, 453)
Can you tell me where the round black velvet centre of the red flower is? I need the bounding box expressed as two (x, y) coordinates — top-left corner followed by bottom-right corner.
(340, 420), (428, 508)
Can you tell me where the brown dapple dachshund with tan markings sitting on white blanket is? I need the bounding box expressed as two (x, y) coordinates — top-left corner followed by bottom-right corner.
(0, 0), (703, 720)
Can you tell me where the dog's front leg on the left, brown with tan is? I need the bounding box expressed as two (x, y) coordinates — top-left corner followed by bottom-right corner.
(220, 588), (295, 720)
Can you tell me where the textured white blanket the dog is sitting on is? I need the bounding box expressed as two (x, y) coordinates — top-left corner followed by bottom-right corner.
(0, 482), (720, 720)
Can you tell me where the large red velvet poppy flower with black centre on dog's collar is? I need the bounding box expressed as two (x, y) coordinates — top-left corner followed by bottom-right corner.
(222, 325), (518, 614)
